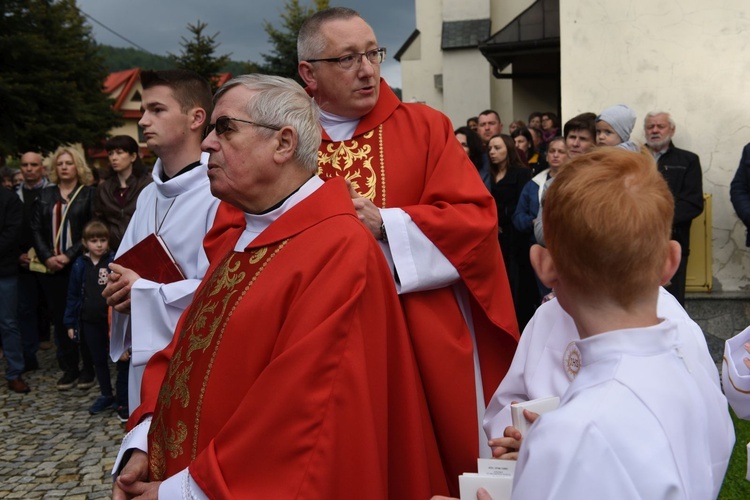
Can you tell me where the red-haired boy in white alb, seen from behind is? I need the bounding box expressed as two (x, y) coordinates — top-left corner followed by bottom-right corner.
(513, 150), (734, 499)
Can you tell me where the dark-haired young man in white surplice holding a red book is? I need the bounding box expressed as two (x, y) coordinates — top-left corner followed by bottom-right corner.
(104, 70), (219, 412)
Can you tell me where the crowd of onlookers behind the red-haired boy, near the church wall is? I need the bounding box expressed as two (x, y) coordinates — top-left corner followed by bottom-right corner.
(454, 104), (703, 330)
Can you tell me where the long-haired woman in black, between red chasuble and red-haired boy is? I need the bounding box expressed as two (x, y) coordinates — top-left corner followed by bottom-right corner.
(487, 134), (538, 329)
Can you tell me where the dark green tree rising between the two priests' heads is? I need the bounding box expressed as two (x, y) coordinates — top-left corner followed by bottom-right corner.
(260, 0), (329, 83)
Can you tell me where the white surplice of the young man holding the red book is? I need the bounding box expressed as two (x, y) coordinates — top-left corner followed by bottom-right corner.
(110, 153), (219, 411)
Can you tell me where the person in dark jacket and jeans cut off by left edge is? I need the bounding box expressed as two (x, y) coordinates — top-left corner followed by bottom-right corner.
(0, 189), (30, 393)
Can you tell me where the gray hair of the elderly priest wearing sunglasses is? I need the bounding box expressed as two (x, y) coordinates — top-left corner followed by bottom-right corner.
(214, 74), (321, 172)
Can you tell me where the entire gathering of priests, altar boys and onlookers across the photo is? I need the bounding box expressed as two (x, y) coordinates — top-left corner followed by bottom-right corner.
(0, 7), (748, 499)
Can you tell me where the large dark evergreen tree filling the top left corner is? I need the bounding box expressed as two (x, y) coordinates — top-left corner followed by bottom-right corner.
(0, 0), (120, 155)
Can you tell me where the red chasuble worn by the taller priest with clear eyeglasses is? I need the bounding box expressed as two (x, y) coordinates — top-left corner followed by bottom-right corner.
(318, 80), (519, 496)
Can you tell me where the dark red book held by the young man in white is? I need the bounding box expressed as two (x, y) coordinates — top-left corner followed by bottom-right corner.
(114, 233), (185, 284)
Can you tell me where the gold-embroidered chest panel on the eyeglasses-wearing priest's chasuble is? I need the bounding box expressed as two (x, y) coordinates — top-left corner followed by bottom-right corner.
(318, 129), (386, 208)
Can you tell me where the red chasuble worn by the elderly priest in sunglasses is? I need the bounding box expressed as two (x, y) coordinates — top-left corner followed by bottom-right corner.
(134, 180), (447, 499)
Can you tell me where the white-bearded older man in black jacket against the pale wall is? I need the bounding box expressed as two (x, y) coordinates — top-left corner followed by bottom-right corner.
(643, 111), (703, 306)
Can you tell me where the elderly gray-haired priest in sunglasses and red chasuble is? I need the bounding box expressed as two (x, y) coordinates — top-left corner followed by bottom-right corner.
(113, 75), (447, 499)
